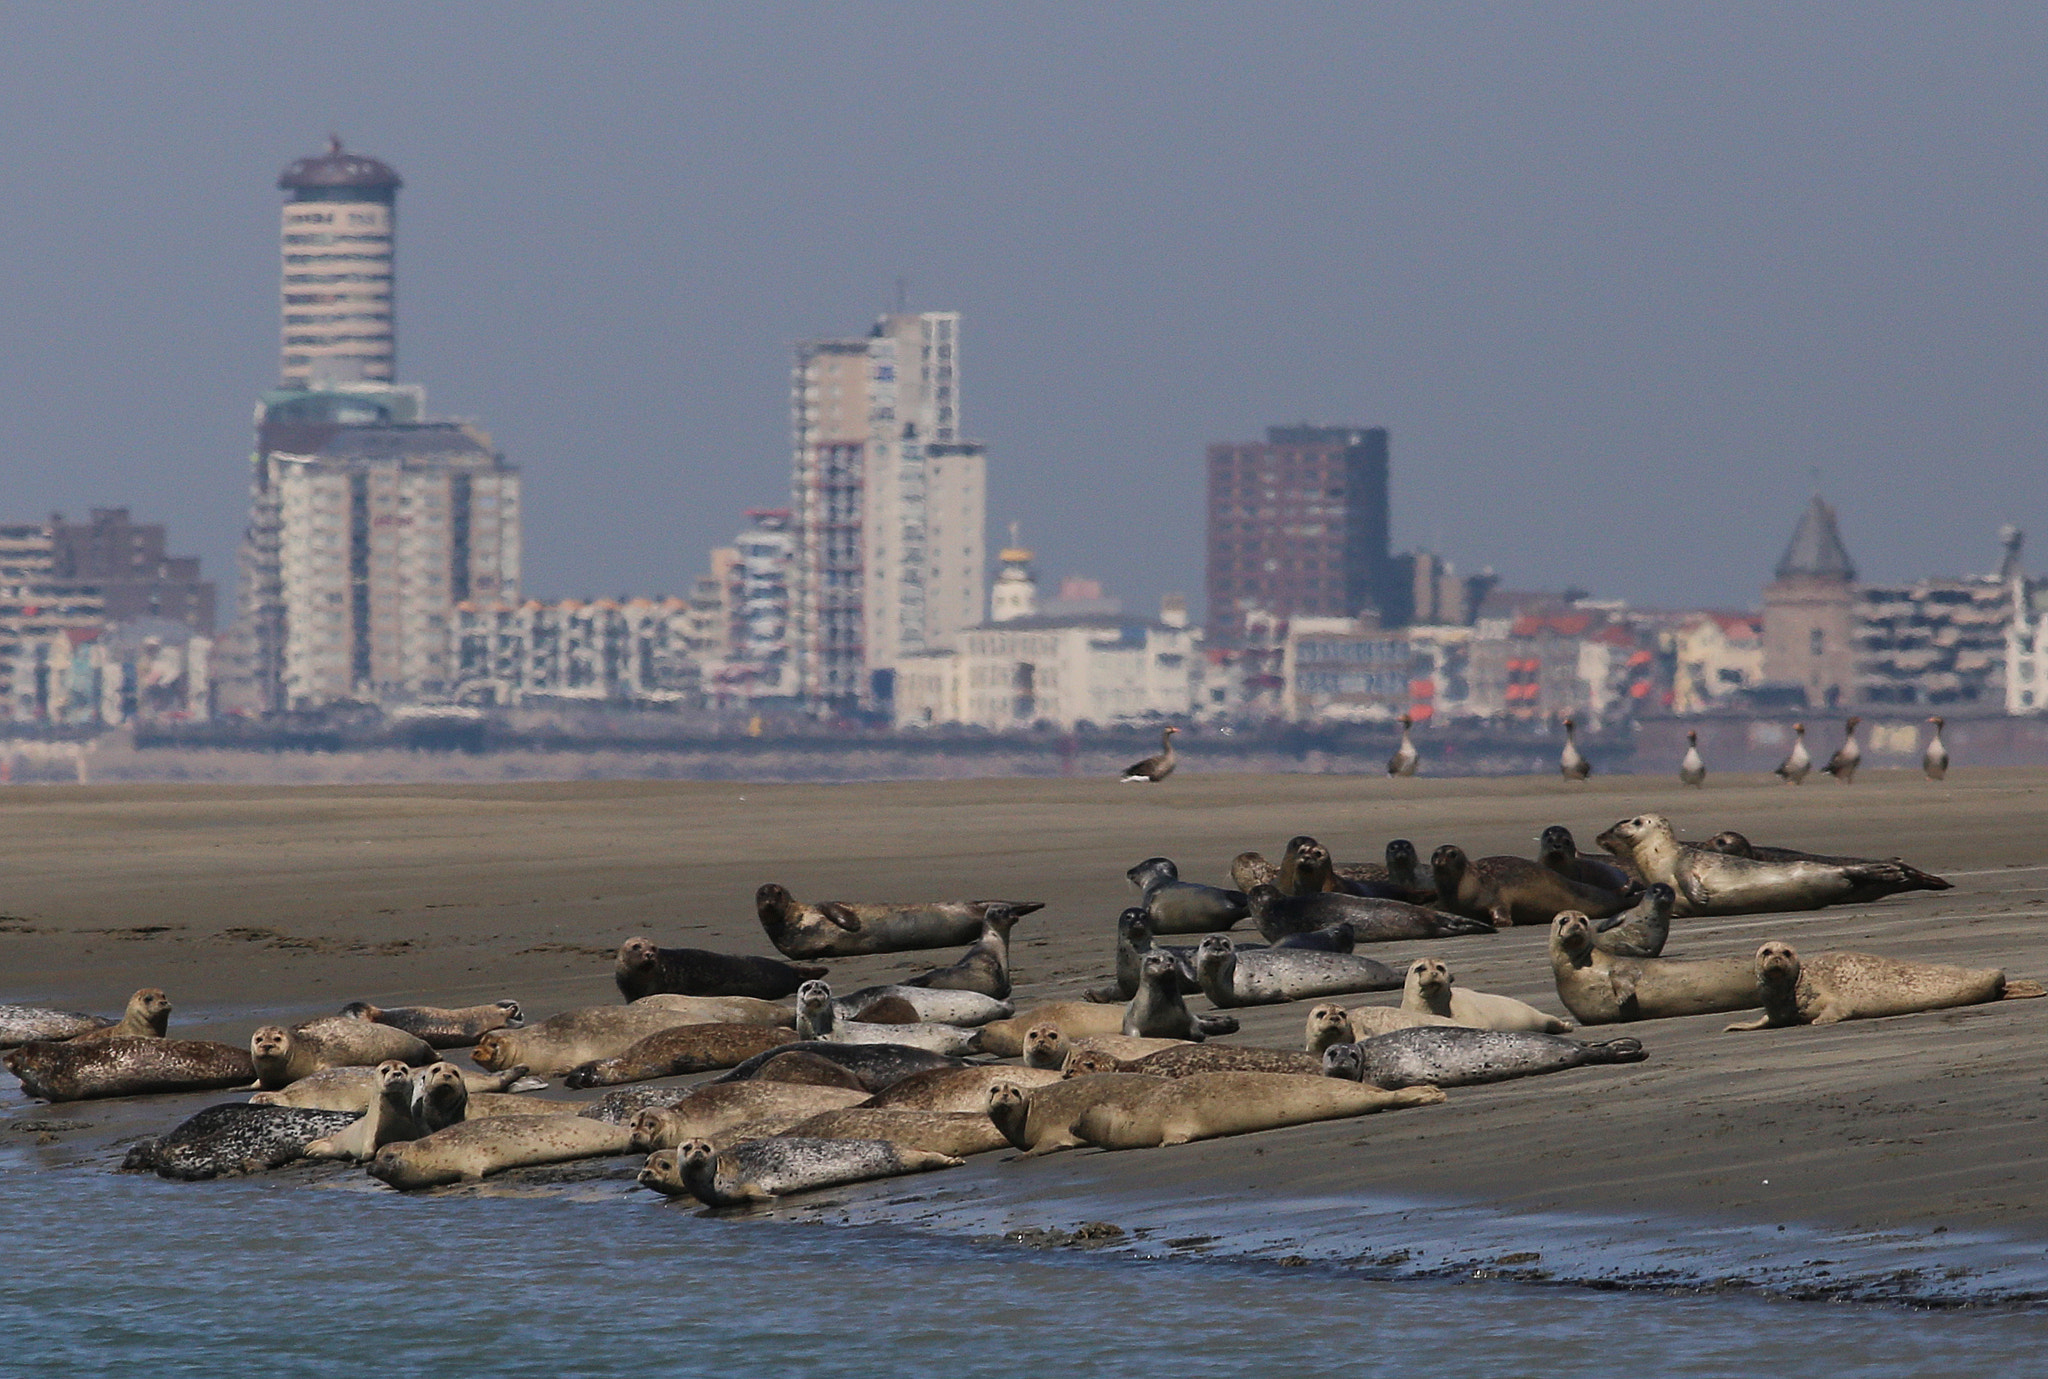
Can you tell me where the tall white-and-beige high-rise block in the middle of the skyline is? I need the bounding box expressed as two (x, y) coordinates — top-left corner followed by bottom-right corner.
(791, 311), (987, 709)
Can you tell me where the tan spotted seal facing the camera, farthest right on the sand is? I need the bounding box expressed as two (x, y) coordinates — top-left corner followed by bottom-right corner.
(1726, 938), (2044, 1031)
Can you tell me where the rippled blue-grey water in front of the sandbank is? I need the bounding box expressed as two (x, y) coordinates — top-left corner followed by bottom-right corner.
(0, 1166), (2048, 1379)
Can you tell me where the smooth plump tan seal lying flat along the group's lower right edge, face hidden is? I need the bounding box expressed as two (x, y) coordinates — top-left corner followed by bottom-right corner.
(1064, 1072), (1444, 1150)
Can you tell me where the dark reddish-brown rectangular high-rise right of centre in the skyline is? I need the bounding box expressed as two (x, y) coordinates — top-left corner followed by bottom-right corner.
(1208, 426), (1409, 645)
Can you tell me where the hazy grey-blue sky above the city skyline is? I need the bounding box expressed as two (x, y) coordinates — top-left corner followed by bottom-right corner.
(0, 2), (2048, 604)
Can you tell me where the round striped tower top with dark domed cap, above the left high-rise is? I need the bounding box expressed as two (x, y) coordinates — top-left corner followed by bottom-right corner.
(276, 139), (401, 387)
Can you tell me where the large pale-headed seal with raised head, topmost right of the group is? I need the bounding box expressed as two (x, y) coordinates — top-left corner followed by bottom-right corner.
(1575, 813), (1948, 916)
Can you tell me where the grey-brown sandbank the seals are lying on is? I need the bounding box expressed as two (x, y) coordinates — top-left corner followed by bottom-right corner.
(0, 770), (2048, 1238)
